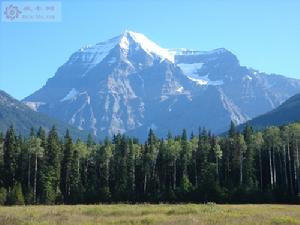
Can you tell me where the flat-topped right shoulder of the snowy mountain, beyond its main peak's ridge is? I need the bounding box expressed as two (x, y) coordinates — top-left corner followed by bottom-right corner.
(176, 49), (300, 119)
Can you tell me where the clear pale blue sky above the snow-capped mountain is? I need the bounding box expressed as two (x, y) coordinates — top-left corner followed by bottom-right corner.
(0, 0), (300, 99)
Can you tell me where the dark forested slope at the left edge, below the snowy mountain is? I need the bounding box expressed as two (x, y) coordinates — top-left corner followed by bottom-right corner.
(0, 90), (87, 139)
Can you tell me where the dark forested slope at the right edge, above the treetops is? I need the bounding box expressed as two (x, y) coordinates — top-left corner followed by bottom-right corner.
(240, 94), (300, 129)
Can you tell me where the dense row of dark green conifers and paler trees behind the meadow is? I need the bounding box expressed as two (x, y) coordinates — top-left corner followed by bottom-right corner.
(0, 123), (300, 205)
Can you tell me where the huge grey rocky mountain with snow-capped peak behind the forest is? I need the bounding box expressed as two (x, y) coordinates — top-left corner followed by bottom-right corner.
(24, 31), (300, 137)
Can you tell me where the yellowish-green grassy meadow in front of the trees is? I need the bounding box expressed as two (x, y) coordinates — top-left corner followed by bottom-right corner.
(0, 204), (300, 225)
